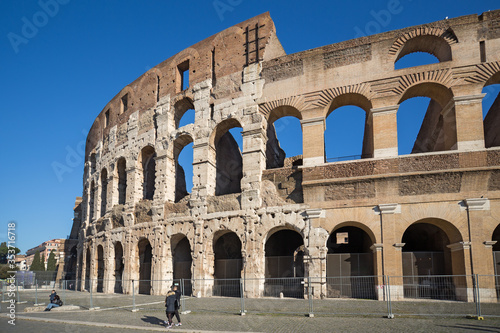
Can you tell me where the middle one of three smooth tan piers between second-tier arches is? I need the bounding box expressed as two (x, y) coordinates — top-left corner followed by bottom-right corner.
(368, 105), (399, 158)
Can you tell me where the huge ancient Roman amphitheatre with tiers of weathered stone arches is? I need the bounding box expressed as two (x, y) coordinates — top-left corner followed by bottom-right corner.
(69, 10), (500, 302)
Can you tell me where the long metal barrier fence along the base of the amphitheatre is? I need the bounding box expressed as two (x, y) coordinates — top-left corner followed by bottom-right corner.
(0, 275), (500, 318)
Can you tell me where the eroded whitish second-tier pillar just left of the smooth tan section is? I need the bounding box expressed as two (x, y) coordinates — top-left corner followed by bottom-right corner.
(241, 122), (266, 209)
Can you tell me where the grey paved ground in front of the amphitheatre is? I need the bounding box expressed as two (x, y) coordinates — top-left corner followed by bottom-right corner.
(0, 293), (500, 333)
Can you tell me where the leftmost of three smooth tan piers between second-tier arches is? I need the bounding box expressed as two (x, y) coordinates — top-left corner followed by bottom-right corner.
(300, 117), (325, 167)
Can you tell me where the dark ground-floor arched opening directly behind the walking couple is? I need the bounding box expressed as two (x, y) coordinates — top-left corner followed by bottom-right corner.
(172, 235), (193, 296)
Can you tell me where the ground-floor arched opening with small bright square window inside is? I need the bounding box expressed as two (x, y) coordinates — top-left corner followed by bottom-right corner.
(326, 226), (377, 299)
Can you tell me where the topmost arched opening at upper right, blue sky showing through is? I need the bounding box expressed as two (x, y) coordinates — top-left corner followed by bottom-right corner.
(394, 32), (452, 69)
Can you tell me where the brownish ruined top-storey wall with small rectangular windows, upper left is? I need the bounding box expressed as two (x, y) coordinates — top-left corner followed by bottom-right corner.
(85, 13), (285, 159)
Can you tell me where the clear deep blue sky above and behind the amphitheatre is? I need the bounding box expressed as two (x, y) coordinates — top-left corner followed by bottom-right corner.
(0, 0), (500, 253)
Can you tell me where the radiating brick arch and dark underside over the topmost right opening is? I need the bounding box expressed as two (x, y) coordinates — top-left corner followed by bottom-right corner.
(389, 27), (458, 62)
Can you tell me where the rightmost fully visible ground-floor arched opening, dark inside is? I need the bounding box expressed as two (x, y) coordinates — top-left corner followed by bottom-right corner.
(402, 222), (456, 300)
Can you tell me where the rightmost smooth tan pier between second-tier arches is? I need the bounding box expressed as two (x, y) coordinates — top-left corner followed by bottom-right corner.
(453, 94), (486, 151)
